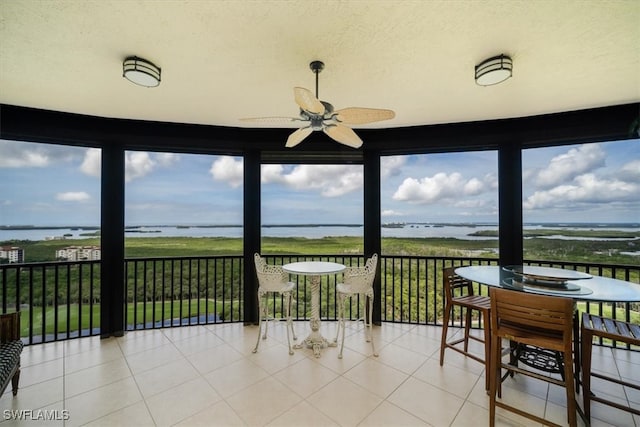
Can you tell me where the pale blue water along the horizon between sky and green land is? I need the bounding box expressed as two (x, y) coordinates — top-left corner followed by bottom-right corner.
(0, 224), (640, 241)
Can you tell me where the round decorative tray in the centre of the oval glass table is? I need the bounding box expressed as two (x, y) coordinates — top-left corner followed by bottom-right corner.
(503, 265), (593, 295)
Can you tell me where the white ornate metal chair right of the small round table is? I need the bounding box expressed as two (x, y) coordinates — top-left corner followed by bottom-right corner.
(333, 254), (378, 359)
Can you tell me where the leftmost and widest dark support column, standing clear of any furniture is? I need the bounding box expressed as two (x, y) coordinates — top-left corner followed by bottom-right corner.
(100, 143), (126, 338)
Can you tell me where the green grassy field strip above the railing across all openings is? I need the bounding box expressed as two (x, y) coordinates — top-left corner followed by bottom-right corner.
(5, 230), (640, 265)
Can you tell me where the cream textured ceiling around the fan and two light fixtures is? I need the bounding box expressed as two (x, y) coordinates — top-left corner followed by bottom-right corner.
(0, 0), (640, 127)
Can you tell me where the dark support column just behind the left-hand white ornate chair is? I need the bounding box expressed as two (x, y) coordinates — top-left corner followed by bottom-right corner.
(243, 151), (261, 325)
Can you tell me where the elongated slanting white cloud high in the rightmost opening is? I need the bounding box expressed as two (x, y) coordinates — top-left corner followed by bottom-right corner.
(535, 144), (607, 189)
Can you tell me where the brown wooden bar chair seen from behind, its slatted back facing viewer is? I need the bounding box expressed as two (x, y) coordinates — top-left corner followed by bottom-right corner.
(489, 288), (578, 426)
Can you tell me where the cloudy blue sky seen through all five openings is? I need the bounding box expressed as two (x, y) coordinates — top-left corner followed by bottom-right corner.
(0, 139), (640, 226)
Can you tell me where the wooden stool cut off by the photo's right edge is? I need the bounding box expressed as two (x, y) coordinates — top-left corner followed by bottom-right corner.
(580, 313), (640, 422)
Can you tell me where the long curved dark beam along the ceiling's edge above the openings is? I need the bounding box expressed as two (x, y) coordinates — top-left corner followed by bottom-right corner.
(0, 103), (640, 158)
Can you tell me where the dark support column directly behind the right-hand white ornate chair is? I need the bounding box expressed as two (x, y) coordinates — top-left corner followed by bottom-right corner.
(364, 150), (382, 325)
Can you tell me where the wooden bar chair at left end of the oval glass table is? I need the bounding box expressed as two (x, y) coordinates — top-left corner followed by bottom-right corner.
(440, 267), (491, 390)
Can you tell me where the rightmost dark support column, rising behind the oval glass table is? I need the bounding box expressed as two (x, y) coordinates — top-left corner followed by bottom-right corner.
(498, 142), (523, 265)
